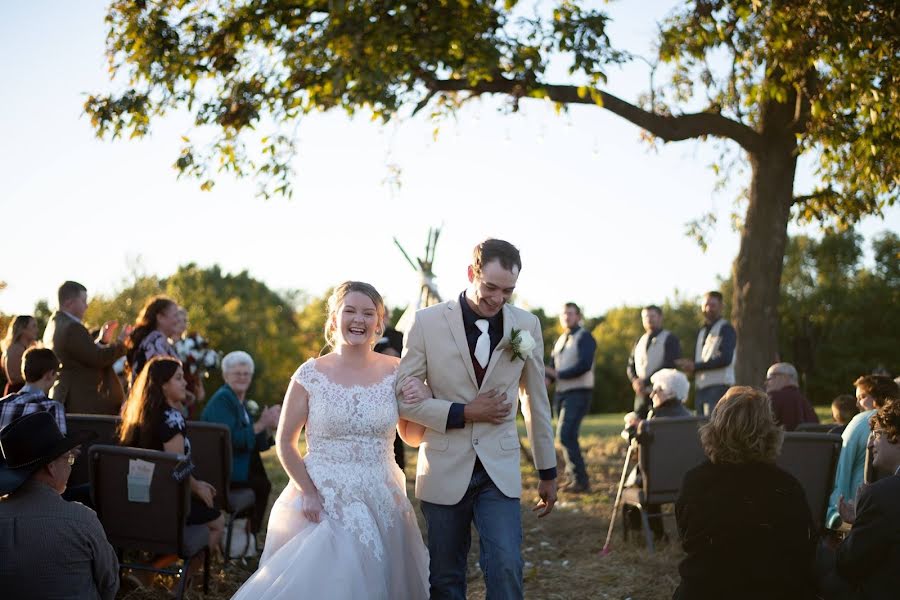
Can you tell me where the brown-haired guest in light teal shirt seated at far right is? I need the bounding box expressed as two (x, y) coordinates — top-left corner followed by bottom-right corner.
(825, 375), (900, 529)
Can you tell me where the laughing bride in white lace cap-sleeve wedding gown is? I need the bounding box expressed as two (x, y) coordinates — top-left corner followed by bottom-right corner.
(234, 281), (428, 600)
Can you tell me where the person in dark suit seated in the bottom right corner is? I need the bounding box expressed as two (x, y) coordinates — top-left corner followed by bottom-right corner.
(823, 398), (900, 600)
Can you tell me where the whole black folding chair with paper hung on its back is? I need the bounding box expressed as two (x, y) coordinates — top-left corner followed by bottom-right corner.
(88, 444), (209, 600)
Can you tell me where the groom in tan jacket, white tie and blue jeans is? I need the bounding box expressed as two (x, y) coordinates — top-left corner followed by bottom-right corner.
(396, 239), (556, 600)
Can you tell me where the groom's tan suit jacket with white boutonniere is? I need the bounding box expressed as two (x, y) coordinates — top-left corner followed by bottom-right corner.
(395, 300), (556, 505)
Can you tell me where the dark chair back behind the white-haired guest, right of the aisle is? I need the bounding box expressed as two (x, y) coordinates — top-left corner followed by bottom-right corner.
(640, 417), (708, 504)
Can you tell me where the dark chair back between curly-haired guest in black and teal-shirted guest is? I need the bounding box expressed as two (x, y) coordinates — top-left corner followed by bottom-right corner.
(775, 431), (841, 529)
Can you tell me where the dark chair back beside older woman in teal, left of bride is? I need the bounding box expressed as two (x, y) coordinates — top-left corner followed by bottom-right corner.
(185, 421), (234, 513)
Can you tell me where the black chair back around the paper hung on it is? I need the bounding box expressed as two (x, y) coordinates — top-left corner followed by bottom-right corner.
(88, 444), (191, 556)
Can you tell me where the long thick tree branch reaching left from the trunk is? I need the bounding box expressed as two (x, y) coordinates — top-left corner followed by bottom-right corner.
(425, 78), (762, 153)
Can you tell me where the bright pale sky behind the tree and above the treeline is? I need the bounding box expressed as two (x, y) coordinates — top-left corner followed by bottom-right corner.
(0, 0), (900, 315)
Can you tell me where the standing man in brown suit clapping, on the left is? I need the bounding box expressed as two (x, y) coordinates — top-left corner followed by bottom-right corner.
(44, 281), (127, 415)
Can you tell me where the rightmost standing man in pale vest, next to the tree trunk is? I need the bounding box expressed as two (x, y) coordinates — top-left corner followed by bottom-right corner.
(676, 292), (737, 416)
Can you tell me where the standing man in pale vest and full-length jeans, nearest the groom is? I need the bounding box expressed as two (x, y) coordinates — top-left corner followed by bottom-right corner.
(546, 302), (597, 494)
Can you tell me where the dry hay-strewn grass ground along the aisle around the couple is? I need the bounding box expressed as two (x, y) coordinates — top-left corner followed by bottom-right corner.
(117, 435), (683, 600)
